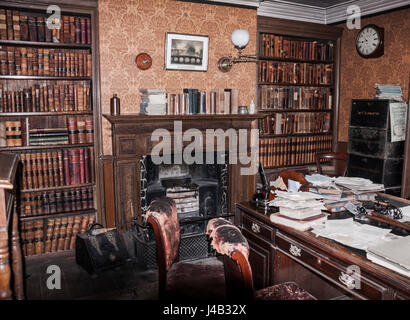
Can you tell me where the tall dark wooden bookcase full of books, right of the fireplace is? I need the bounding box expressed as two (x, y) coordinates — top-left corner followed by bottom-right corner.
(257, 17), (342, 170)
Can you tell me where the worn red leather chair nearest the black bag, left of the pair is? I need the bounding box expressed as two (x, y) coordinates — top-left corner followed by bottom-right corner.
(147, 198), (226, 301)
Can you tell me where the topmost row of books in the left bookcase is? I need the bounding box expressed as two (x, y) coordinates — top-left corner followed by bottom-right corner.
(0, 9), (91, 44)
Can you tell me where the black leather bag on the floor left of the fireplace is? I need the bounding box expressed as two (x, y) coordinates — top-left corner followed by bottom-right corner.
(75, 223), (128, 274)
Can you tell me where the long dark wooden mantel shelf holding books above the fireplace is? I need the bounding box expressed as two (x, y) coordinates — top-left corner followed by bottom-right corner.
(103, 114), (266, 124)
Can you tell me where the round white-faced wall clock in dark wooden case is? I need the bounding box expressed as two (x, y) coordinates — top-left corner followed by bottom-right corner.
(356, 24), (384, 59)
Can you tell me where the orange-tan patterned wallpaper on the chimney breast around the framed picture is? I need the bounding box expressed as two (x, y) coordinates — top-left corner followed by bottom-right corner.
(98, 0), (256, 154)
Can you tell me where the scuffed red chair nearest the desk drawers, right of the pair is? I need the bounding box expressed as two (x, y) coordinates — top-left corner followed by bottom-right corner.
(207, 218), (316, 300)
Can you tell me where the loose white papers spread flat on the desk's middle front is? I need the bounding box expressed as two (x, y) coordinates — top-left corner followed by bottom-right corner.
(312, 218), (391, 250)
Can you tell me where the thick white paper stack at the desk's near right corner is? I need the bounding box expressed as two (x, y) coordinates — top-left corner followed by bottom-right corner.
(366, 236), (410, 277)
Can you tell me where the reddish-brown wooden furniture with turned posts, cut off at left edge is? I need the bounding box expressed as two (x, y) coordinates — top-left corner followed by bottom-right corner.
(0, 153), (24, 300)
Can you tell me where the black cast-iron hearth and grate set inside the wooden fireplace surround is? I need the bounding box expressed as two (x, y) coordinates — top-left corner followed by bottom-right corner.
(136, 153), (229, 267)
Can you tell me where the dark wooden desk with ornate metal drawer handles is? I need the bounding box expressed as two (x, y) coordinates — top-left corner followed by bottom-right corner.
(235, 196), (410, 300)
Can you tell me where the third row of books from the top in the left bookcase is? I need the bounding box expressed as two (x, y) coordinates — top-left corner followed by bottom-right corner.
(0, 80), (91, 112)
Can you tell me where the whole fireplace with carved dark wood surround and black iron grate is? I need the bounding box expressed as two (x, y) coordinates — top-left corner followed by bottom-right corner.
(102, 115), (260, 266)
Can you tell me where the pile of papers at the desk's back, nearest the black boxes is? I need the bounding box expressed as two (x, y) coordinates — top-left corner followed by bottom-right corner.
(305, 174), (384, 212)
